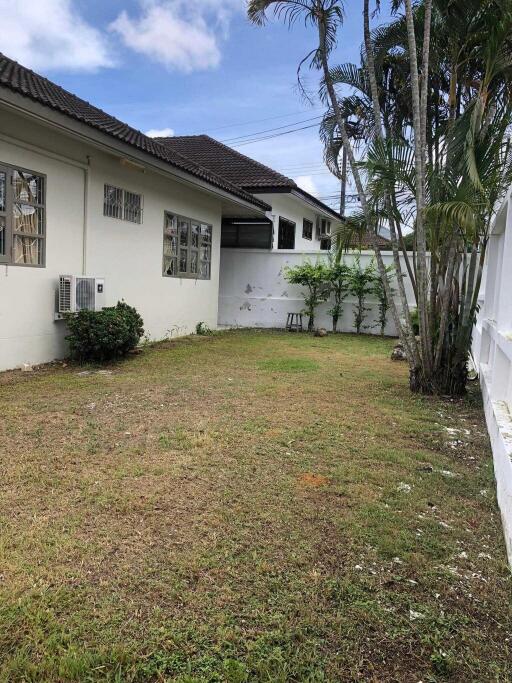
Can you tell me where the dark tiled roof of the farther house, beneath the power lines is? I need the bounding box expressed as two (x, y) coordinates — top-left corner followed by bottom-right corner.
(156, 135), (339, 218)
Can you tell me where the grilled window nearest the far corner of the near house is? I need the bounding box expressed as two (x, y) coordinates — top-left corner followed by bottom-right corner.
(163, 212), (212, 280)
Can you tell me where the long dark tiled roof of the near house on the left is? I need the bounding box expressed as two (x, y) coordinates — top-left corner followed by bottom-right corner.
(0, 53), (271, 211)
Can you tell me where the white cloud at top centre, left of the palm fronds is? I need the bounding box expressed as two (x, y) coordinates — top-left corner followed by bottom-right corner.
(109, 0), (244, 73)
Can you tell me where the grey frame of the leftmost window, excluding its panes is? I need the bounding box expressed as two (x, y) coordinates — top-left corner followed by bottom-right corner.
(0, 161), (47, 268)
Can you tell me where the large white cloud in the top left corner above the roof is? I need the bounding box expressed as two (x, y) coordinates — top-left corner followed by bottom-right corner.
(0, 0), (113, 71)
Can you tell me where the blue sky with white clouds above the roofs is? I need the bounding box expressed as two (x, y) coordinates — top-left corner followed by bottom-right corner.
(0, 0), (394, 211)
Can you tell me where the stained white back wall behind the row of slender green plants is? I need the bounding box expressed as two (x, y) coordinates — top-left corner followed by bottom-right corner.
(219, 249), (415, 335)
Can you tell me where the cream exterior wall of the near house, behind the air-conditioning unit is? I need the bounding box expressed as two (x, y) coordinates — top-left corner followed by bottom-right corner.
(0, 112), (226, 370)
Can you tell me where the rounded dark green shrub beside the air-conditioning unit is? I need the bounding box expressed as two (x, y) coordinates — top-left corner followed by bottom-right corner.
(66, 301), (144, 362)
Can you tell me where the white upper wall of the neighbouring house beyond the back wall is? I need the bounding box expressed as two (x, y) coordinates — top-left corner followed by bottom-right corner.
(255, 192), (336, 252)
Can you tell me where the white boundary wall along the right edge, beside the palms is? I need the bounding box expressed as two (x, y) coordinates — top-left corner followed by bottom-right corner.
(473, 193), (512, 564)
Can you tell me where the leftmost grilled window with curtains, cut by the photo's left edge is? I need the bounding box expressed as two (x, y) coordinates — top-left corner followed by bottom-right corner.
(0, 165), (46, 266)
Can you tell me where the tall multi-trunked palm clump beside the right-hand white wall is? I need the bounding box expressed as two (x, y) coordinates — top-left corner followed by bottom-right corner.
(249, 0), (512, 395)
